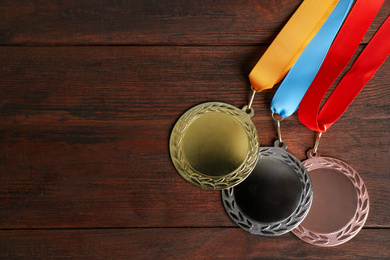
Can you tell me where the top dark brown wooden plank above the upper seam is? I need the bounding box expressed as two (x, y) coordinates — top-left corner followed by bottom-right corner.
(0, 0), (390, 45)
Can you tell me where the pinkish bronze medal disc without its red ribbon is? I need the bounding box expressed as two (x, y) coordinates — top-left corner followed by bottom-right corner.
(293, 150), (369, 247)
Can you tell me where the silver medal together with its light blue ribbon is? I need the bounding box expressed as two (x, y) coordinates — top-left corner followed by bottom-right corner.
(222, 0), (353, 236)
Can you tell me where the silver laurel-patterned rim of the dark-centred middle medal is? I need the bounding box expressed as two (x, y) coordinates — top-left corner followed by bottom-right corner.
(222, 147), (313, 236)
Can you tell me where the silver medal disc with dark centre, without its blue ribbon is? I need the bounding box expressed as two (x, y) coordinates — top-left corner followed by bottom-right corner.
(222, 141), (313, 236)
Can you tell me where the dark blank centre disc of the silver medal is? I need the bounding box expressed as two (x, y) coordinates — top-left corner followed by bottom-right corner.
(234, 157), (302, 223)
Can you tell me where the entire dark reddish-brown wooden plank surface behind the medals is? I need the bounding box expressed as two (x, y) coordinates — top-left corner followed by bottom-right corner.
(0, 0), (390, 259)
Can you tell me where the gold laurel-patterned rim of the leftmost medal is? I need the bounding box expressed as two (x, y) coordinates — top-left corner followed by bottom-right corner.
(169, 102), (260, 190)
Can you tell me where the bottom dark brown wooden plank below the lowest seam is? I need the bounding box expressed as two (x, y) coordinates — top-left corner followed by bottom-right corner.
(0, 228), (390, 259)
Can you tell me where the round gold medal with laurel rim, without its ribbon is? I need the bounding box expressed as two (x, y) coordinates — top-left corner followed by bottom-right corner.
(169, 102), (260, 190)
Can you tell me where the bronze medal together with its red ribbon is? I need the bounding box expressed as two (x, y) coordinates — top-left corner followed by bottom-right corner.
(293, 1), (390, 246)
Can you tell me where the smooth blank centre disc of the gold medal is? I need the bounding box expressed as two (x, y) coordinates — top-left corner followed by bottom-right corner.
(182, 112), (249, 176)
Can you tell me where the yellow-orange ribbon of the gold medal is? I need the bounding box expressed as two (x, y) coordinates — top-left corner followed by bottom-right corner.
(249, 0), (338, 91)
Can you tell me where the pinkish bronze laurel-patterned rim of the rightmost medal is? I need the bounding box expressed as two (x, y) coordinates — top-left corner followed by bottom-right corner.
(292, 156), (370, 247)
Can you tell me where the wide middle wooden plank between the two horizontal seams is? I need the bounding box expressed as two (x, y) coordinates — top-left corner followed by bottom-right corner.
(0, 46), (390, 228)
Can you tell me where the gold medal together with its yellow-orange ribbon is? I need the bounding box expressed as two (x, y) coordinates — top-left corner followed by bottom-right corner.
(169, 0), (337, 190)
